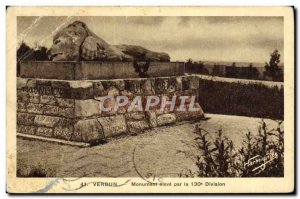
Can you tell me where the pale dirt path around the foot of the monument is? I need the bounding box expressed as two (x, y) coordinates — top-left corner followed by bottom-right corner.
(17, 114), (275, 177)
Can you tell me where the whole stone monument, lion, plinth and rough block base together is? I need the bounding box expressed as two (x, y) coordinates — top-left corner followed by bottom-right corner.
(17, 21), (204, 145)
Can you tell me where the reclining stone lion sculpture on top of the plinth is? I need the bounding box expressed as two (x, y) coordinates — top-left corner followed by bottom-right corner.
(50, 21), (170, 62)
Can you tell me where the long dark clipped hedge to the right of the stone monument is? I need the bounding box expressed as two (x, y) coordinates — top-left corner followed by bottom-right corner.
(199, 79), (284, 120)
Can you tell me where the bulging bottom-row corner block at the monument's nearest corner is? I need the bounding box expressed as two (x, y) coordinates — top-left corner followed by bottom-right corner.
(71, 119), (104, 142)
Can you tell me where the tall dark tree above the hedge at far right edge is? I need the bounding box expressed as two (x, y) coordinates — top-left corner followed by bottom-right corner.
(264, 50), (283, 81)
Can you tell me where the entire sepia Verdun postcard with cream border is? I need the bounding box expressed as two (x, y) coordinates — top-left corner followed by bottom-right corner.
(7, 7), (294, 193)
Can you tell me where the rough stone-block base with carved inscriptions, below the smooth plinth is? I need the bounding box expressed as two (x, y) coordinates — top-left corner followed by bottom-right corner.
(17, 74), (204, 144)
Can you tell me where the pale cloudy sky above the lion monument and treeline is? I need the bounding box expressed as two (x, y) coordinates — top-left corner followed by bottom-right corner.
(17, 16), (284, 63)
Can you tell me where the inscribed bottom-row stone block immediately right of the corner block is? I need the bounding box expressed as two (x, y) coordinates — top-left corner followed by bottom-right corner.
(98, 115), (127, 138)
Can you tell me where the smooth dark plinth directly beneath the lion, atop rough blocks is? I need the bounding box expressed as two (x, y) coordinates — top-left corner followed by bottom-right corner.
(20, 61), (184, 80)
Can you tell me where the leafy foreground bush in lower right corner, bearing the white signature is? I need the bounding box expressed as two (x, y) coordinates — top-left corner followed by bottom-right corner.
(181, 120), (284, 177)
